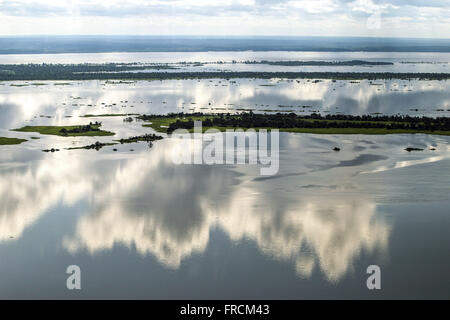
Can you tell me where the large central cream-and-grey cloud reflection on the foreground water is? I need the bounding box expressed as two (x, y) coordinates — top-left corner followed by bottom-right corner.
(51, 139), (390, 281)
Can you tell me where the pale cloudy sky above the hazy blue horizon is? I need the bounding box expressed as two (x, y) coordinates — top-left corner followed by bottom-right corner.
(0, 0), (450, 38)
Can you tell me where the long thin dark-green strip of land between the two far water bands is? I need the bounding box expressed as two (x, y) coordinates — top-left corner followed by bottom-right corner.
(0, 62), (450, 80)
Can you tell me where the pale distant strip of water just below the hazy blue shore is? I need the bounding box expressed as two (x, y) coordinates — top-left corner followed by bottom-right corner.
(0, 51), (450, 73)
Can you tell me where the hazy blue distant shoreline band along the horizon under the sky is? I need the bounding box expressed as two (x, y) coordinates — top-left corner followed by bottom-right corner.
(0, 35), (450, 55)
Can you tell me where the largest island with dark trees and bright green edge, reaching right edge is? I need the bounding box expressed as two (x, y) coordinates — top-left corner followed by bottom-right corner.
(138, 112), (450, 135)
